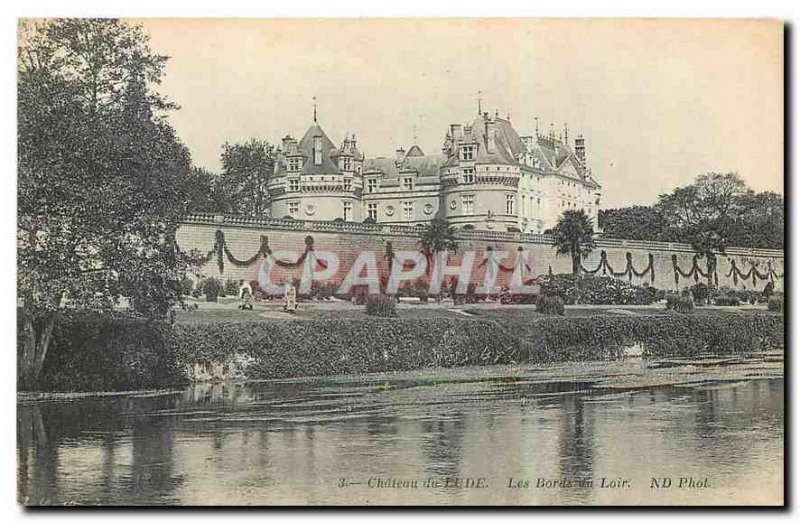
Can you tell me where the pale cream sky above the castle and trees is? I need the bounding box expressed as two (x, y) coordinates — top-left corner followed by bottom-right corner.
(136, 19), (783, 208)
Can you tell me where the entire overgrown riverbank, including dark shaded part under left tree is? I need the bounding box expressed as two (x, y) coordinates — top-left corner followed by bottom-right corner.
(17, 305), (784, 392)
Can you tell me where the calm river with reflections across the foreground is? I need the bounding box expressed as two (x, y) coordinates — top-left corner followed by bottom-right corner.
(17, 352), (784, 505)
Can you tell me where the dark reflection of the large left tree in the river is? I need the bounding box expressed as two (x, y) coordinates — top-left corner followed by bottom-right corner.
(18, 396), (184, 504)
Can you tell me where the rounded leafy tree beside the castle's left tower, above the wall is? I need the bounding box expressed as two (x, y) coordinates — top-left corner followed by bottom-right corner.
(221, 139), (275, 217)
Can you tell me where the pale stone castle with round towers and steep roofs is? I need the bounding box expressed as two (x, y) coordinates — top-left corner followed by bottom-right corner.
(268, 112), (602, 233)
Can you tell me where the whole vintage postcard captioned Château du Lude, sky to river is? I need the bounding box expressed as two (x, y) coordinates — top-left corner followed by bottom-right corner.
(16, 18), (786, 506)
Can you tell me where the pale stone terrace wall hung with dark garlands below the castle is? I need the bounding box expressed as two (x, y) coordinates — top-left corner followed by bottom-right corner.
(176, 214), (784, 290)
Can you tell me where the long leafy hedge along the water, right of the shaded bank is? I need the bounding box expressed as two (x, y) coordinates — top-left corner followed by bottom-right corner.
(167, 313), (784, 379)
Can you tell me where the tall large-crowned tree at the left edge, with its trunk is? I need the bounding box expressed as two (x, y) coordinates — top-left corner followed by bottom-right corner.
(17, 19), (189, 386)
